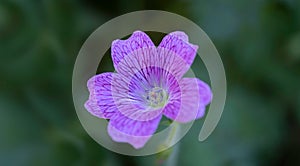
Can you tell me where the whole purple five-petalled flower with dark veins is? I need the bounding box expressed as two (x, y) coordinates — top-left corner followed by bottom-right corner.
(85, 31), (212, 149)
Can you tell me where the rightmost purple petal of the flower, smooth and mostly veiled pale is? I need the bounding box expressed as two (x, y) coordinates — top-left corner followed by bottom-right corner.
(163, 78), (211, 123)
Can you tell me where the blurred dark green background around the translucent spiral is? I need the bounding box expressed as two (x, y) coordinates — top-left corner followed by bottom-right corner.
(0, 0), (300, 166)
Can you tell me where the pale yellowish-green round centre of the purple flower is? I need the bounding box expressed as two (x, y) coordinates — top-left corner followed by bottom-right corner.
(146, 87), (169, 108)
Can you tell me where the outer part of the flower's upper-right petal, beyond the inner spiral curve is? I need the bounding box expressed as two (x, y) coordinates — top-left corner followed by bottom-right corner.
(157, 31), (198, 74)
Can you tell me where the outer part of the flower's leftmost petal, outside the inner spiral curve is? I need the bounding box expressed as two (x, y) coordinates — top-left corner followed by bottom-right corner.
(84, 73), (117, 119)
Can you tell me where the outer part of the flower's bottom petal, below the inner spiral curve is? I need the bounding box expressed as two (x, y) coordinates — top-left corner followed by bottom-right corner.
(107, 113), (161, 149)
